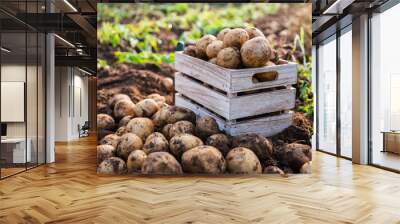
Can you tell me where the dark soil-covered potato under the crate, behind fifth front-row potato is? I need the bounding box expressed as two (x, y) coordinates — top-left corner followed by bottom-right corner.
(232, 134), (272, 162)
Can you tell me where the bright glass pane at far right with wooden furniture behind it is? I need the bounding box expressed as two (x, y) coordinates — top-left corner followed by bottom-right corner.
(370, 5), (400, 171)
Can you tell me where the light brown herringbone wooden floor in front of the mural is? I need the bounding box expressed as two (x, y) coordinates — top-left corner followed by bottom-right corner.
(0, 138), (400, 224)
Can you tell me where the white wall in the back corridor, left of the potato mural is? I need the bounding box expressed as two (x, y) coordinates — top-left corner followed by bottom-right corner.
(55, 67), (88, 141)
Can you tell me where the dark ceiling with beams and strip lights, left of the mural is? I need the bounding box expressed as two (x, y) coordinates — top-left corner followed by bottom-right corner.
(0, 0), (97, 73)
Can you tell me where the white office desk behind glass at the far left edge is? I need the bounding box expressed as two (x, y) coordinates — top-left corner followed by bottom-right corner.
(1, 138), (32, 163)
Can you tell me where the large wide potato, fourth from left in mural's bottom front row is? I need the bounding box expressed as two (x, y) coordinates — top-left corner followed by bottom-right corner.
(182, 145), (226, 174)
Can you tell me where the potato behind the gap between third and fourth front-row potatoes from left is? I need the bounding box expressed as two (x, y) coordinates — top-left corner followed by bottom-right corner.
(169, 134), (203, 160)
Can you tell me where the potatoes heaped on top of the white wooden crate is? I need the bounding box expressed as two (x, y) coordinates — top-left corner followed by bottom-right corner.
(184, 27), (288, 69)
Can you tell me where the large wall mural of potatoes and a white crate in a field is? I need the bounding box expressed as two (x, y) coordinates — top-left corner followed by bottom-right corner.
(97, 3), (313, 175)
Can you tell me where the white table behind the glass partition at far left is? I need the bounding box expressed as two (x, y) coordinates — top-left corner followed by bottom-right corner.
(1, 138), (32, 163)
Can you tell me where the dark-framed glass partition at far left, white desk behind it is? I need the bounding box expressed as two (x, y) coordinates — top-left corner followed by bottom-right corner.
(0, 1), (46, 179)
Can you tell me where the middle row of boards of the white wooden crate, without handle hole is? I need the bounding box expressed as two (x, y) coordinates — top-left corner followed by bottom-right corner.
(175, 73), (296, 120)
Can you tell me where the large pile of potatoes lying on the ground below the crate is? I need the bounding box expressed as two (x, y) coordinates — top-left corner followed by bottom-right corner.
(97, 94), (311, 175)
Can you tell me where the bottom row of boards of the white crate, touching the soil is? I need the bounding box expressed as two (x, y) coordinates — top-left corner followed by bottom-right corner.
(175, 93), (293, 137)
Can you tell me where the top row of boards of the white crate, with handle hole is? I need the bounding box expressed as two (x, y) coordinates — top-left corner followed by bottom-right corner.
(175, 52), (297, 93)
